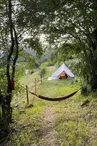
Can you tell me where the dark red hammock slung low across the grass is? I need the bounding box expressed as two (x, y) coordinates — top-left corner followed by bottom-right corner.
(29, 89), (80, 101)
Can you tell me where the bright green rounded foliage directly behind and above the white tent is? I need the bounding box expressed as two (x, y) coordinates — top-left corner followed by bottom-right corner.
(51, 43), (81, 65)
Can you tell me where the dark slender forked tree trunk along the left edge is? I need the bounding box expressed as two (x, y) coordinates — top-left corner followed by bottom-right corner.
(1, 0), (18, 132)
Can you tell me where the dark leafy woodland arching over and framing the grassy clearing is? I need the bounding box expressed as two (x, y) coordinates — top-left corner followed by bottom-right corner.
(0, 0), (97, 143)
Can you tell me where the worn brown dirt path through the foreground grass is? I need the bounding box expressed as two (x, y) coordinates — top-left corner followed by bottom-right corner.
(42, 107), (59, 146)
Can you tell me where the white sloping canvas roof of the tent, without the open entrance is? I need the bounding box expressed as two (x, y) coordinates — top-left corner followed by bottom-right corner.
(52, 63), (74, 78)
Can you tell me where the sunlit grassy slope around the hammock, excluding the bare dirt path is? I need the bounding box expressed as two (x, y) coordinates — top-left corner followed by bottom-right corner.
(8, 68), (97, 146)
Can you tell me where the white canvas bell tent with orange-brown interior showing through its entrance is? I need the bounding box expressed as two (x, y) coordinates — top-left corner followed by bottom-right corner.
(49, 64), (74, 80)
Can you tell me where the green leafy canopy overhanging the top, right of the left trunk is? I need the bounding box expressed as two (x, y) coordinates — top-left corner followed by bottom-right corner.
(1, 0), (97, 91)
